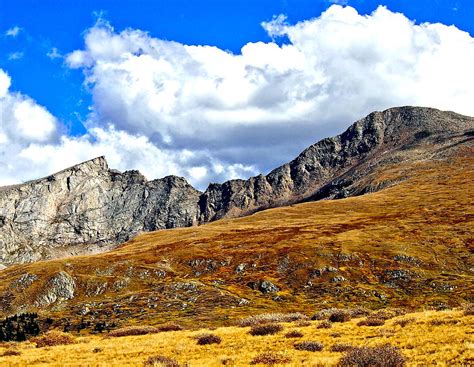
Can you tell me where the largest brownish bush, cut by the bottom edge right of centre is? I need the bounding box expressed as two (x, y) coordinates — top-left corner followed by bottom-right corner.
(339, 344), (406, 367)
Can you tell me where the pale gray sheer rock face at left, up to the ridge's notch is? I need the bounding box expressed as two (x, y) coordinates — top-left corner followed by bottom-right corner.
(0, 157), (200, 265)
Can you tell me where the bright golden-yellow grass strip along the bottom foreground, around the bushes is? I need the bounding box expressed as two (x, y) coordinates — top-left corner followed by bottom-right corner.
(0, 310), (474, 367)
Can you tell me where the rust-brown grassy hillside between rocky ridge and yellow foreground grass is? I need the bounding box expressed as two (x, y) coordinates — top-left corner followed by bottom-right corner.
(0, 142), (474, 328)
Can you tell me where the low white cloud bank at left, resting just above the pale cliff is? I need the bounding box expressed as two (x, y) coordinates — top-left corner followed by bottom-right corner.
(0, 69), (255, 187)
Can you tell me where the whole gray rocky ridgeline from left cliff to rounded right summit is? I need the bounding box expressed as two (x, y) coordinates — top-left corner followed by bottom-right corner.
(0, 107), (474, 267)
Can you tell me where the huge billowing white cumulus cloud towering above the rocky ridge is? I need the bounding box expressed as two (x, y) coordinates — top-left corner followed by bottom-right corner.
(0, 5), (474, 188)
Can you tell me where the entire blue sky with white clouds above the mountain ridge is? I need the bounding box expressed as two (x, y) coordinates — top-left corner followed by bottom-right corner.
(0, 0), (474, 189)
